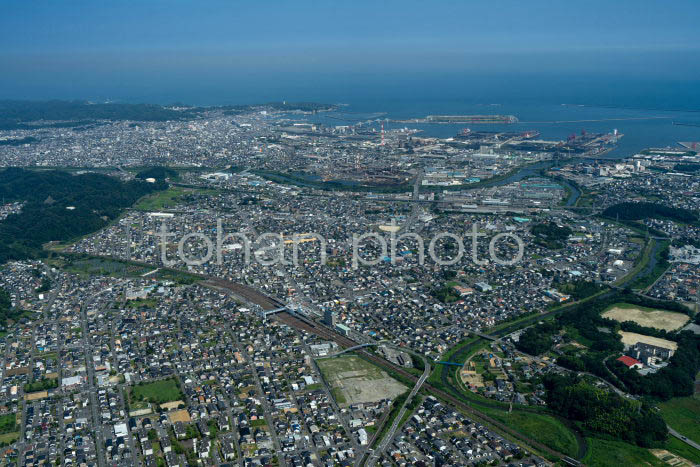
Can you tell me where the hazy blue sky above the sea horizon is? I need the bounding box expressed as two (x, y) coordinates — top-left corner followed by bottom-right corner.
(0, 0), (700, 102)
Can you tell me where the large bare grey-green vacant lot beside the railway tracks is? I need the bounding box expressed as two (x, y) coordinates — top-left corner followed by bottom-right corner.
(317, 355), (406, 406)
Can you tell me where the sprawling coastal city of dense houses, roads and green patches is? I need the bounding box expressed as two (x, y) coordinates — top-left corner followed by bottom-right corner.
(0, 99), (700, 467)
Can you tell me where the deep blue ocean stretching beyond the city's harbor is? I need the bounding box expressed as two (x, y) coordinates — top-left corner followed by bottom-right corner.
(45, 72), (700, 158)
